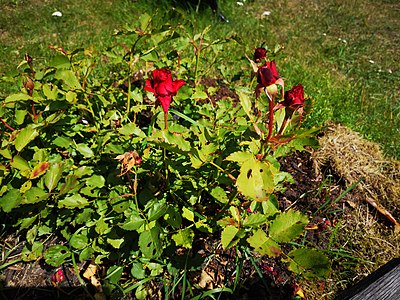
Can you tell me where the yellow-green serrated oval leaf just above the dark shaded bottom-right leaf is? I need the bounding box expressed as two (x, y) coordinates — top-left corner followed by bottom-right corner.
(268, 210), (308, 242)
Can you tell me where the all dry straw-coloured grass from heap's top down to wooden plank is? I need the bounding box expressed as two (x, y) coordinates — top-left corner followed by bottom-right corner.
(304, 124), (400, 299)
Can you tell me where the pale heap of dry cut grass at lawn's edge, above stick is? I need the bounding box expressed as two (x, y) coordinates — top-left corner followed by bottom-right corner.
(314, 124), (400, 230)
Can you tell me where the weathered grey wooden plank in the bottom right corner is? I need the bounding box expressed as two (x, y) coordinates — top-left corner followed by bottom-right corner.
(335, 258), (400, 300)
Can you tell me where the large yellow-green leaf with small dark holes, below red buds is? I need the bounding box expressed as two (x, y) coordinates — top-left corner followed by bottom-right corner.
(236, 158), (275, 202)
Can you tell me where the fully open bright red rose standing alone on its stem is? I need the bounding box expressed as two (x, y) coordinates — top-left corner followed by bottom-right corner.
(144, 68), (185, 113)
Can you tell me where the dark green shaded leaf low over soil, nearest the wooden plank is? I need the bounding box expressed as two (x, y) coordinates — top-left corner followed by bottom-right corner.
(284, 248), (330, 279)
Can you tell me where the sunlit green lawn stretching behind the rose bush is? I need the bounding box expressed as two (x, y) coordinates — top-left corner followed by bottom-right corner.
(0, 0), (400, 158)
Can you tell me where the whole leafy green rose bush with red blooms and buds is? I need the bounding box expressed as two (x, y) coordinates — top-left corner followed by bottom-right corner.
(0, 15), (330, 298)
